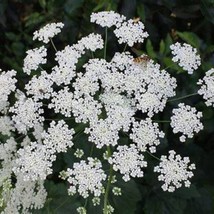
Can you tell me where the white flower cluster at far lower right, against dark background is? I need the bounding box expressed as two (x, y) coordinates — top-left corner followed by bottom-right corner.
(154, 150), (195, 192)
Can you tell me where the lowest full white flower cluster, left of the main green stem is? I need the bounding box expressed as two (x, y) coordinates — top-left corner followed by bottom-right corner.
(67, 157), (106, 198)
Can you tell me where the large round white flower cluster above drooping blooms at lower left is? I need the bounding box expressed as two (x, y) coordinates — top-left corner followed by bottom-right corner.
(13, 142), (56, 181)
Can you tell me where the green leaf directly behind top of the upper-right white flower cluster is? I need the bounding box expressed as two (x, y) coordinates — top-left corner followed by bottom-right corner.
(177, 31), (200, 49)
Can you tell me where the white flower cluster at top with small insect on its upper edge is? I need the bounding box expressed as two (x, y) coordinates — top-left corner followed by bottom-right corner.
(114, 19), (149, 47)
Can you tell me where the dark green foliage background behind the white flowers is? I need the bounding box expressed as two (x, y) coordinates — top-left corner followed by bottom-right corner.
(0, 0), (214, 214)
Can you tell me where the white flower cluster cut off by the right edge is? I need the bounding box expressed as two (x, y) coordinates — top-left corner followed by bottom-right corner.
(197, 68), (214, 107)
